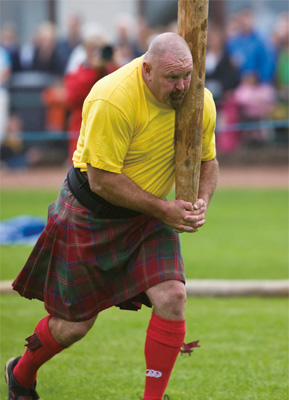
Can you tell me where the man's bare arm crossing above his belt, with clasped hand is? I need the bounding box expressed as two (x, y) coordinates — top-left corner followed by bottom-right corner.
(87, 164), (203, 232)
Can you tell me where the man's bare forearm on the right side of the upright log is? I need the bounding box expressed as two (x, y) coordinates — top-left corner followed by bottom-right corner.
(198, 158), (219, 208)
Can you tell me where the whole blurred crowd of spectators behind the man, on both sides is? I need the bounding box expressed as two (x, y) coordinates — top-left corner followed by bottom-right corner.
(0, 10), (289, 167)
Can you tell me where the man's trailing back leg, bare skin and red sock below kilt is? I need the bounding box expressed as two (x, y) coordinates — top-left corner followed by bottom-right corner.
(13, 316), (96, 388)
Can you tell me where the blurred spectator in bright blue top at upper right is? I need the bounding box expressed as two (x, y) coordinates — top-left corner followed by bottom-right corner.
(226, 9), (276, 83)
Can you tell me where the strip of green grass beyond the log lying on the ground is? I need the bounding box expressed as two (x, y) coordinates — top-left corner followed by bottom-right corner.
(0, 189), (288, 280)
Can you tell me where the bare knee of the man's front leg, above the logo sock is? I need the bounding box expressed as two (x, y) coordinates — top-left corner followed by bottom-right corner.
(147, 280), (186, 320)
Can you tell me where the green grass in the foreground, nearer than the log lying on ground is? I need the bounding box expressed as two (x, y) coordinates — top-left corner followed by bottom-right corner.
(0, 295), (288, 400)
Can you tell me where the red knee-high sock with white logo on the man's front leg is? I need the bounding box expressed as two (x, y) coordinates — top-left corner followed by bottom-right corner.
(143, 314), (186, 400)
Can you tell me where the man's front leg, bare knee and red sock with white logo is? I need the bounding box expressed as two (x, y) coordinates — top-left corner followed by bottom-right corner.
(143, 280), (186, 400)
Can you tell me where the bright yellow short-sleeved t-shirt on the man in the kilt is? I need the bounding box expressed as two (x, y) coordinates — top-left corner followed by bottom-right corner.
(73, 57), (216, 199)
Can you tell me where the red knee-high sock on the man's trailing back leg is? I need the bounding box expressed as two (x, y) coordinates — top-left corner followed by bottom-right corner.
(13, 315), (65, 388)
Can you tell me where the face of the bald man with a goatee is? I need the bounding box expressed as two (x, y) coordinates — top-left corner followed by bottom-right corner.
(143, 52), (193, 108)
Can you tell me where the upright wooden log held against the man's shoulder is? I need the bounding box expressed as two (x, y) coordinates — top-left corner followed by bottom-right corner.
(175, 0), (209, 203)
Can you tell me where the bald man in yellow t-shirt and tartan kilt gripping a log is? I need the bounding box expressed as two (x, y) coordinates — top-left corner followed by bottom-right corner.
(6, 33), (218, 400)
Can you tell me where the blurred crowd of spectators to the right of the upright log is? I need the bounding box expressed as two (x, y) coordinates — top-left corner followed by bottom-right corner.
(206, 9), (289, 153)
